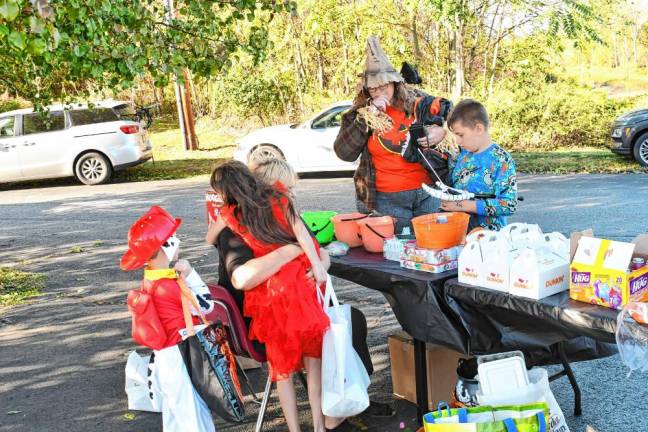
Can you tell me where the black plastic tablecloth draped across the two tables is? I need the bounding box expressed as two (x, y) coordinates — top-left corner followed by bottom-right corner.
(329, 249), (618, 365)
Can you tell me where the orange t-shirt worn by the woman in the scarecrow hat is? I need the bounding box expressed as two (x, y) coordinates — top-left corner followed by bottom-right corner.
(368, 106), (431, 192)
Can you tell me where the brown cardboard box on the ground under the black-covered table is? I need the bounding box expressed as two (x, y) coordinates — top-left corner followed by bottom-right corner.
(388, 331), (466, 410)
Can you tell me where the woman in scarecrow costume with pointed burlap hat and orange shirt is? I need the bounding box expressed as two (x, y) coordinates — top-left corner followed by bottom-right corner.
(334, 36), (452, 232)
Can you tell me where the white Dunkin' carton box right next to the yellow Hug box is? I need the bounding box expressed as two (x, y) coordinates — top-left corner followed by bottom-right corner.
(509, 246), (569, 300)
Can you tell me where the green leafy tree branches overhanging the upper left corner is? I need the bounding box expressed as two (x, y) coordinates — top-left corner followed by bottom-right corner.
(0, 0), (294, 105)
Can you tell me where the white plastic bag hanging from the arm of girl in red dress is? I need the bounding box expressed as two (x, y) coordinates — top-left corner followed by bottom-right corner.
(317, 276), (369, 417)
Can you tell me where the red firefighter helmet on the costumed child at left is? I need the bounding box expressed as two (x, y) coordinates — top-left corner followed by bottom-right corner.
(120, 206), (182, 270)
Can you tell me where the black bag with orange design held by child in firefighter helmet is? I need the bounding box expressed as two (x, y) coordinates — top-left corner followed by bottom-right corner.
(178, 323), (245, 423)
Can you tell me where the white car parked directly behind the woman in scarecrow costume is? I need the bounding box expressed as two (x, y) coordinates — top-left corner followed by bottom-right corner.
(234, 101), (358, 173)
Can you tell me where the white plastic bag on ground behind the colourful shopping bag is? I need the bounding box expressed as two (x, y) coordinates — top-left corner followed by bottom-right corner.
(477, 368), (569, 432)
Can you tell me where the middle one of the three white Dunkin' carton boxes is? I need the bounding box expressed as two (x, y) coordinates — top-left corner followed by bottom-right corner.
(479, 232), (518, 292)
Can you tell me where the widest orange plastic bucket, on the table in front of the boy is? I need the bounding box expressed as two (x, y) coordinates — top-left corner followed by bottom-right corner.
(412, 212), (470, 249)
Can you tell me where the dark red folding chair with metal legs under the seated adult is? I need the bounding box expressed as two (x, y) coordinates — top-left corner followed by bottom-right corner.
(206, 284), (272, 432)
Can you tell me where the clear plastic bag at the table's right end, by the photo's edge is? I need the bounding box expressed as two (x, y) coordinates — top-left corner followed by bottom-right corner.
(616, 302), (648, 373)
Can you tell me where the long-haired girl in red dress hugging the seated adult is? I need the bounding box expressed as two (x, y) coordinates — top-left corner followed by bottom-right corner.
(208, 161), (329, 432)
